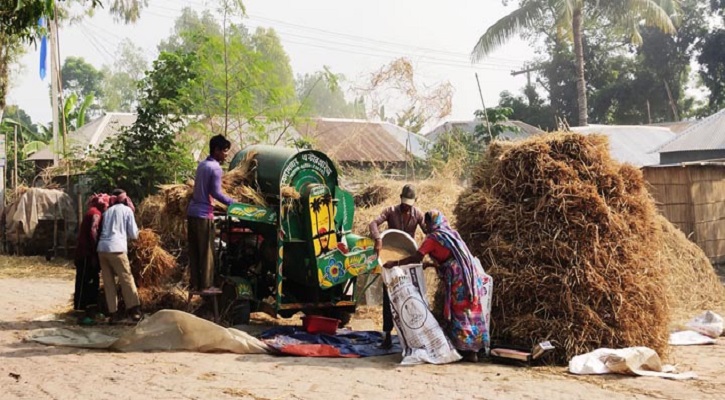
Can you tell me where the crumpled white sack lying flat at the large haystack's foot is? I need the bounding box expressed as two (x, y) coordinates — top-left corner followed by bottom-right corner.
(569, 347), (697, 380)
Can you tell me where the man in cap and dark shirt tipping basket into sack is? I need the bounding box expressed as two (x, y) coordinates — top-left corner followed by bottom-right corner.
(370, 184), (424, 348)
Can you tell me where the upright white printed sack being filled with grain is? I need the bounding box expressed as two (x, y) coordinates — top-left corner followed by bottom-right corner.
(382, 264), (461, 365)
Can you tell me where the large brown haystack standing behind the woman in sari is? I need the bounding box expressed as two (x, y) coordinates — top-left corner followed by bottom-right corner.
(455, 133), (669, 363)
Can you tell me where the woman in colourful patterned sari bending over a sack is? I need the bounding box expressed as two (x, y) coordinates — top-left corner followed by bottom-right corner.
(384, 210), (492, 362)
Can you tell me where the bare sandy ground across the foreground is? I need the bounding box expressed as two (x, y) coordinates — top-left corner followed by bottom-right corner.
(0, 278), (725, 400)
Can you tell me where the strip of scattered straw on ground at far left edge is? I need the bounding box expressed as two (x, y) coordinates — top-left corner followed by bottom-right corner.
(0, 256), (75, 279)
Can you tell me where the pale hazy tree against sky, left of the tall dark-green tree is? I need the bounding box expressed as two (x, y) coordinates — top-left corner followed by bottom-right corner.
(101, 39), (148, 112)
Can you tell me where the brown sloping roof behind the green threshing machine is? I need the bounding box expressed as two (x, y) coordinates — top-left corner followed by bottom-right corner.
(298, 118), (406, 162)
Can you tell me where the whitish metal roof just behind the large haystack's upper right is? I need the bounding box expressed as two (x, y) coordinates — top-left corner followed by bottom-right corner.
(571, 125), (676, 167)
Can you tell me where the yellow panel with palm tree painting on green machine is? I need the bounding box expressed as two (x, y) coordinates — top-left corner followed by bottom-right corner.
(309, 185), (337, 257)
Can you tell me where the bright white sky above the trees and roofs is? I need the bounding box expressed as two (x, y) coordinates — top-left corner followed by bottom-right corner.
(8, 0), (534, 130)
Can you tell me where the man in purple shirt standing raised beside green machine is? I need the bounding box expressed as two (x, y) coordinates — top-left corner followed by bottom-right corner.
(186, 135), (233, 293)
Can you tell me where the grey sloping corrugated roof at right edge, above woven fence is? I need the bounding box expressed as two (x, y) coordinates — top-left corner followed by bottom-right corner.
(657, 108), (725, 153)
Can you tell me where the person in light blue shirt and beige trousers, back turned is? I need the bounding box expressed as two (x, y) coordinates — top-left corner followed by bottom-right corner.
(98, 189), (141, 323)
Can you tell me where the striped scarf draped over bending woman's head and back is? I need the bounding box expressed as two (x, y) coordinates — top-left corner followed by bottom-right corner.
(426, 210), (476, 300)
